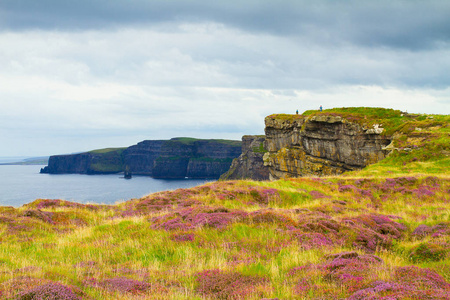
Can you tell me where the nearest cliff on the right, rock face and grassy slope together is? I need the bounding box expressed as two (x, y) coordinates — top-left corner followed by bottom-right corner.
(264, 107), (450, 179)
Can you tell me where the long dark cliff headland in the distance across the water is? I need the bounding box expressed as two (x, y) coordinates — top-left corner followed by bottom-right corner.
(41, 138), (241, 179)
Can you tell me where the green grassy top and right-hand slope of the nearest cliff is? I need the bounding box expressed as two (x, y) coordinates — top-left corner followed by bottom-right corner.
(268, 107), (450, 176)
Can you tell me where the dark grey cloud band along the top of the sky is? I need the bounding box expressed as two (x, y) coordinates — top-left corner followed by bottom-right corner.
(0, 0), (450, 49)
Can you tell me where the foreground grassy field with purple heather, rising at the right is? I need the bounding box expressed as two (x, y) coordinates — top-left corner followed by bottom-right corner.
(0, 109), (450, 300)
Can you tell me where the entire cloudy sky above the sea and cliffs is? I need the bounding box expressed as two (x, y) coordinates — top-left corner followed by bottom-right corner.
(0, 0), (450, 156)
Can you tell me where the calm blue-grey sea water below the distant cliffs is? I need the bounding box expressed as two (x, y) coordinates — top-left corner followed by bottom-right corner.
(0, 165), (211, 207)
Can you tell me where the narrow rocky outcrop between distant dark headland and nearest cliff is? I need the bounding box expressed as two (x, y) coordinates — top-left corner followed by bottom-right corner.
(220, 135), (269, 180)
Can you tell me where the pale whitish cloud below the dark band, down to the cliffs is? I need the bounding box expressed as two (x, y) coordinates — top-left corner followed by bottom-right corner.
(0, 23), (450, 156)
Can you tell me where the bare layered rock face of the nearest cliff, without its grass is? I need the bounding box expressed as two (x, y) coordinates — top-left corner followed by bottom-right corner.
(264, 115), (391, 179)
